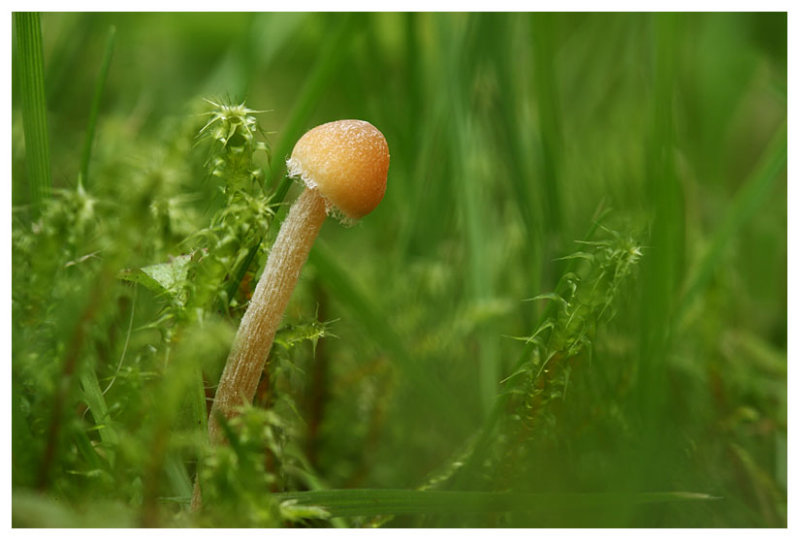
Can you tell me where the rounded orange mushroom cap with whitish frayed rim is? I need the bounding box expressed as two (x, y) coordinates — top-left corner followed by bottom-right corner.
(286, 120), (389, 220)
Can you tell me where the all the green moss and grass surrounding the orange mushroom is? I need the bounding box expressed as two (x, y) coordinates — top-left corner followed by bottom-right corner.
(11, 13), (787, 527)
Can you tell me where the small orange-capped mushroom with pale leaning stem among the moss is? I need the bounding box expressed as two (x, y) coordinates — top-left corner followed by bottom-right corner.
(202, 120), (389, 444)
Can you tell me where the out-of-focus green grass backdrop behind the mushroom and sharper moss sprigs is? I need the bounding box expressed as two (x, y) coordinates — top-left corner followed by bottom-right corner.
(12, 13), (787, 527)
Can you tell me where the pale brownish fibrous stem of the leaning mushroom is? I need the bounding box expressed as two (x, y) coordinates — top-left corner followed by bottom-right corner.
(208, 189), (326, 445)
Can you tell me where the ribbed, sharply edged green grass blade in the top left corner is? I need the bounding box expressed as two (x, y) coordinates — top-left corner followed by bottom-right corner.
(14, 13), (51, 216)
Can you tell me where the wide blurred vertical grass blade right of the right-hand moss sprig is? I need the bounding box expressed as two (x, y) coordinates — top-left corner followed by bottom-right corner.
(629, 9), (685, 506)
